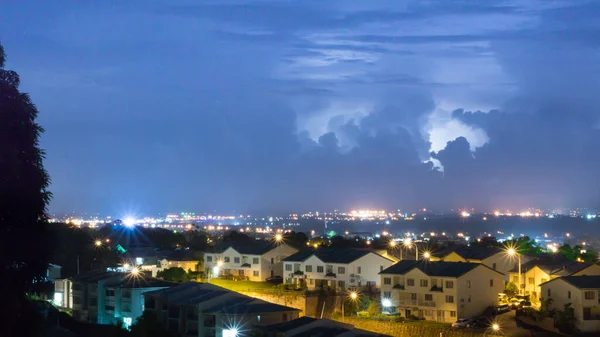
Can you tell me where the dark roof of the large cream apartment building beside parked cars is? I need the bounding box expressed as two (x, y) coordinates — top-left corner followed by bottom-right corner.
(379, 260), (492, 277)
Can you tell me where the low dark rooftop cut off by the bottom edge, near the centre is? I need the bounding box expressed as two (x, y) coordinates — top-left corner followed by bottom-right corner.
(254, 316), (384, 337)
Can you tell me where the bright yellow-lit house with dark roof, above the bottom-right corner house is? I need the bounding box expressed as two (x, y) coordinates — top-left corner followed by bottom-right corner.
(509, 255), (600, 298)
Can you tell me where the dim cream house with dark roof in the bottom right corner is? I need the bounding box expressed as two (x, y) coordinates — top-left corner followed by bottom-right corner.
(541, 275), (600, 333)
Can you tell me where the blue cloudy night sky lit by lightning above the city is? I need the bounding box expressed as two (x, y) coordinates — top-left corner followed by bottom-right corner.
(0, 0), (600, 214)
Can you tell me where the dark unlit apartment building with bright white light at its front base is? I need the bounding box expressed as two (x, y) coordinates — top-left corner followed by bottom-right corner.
(144, 282), (300, 337)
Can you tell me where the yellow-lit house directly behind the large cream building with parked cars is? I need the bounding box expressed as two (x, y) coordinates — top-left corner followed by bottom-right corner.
(430, 245), (530, 281)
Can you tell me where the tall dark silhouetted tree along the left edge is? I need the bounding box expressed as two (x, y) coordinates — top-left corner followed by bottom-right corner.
(0, 45), (51, 336)
